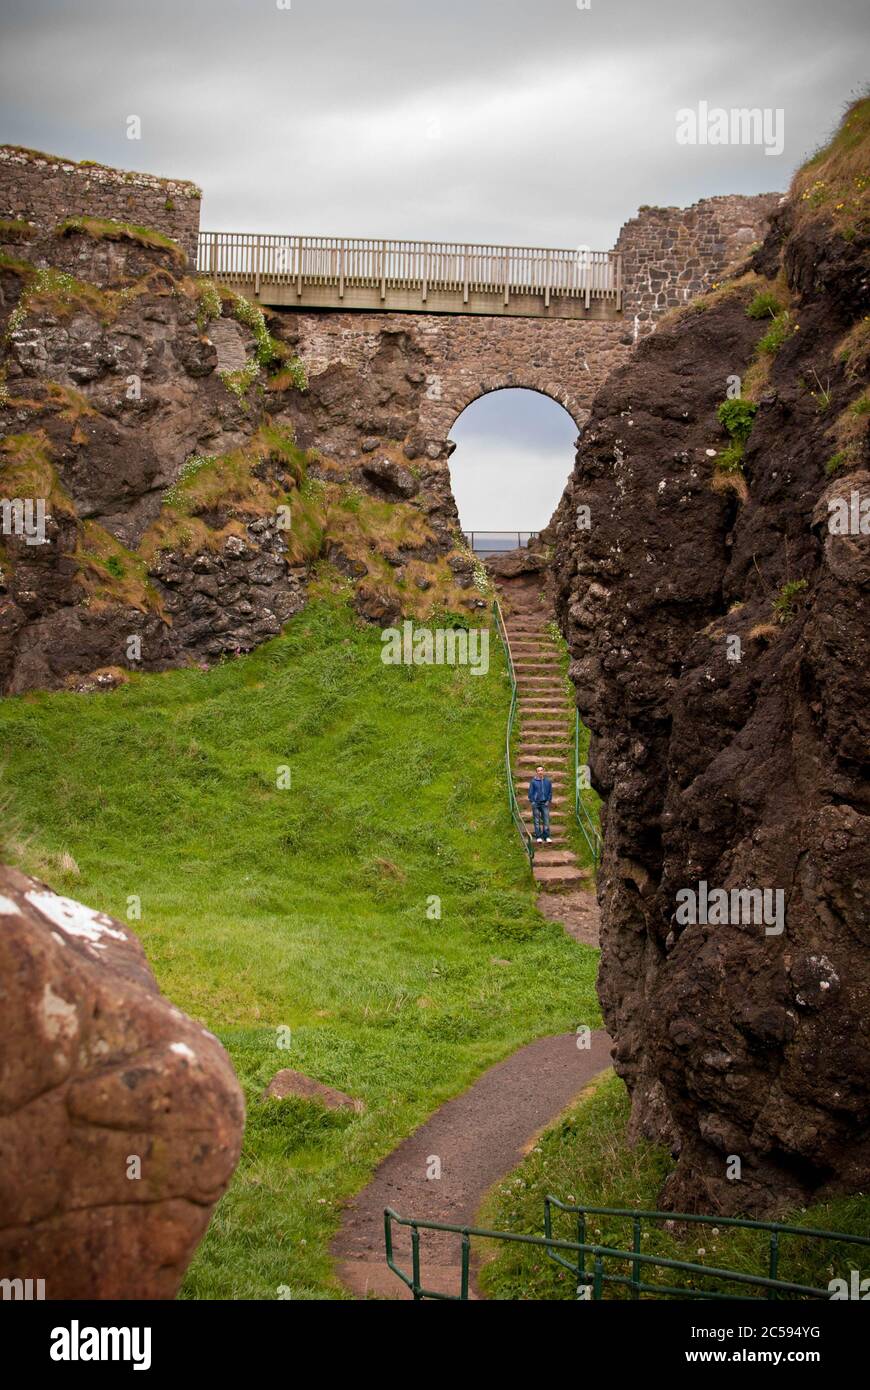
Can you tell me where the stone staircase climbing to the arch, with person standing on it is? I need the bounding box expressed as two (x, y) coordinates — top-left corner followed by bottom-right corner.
(504, 591), (591, 888)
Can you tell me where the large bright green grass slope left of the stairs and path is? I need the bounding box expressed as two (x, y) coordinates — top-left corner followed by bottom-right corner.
(0, 585), (600, 1300)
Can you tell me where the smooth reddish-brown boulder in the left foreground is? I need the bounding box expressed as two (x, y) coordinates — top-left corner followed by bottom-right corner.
(0, 869), (245, 1298)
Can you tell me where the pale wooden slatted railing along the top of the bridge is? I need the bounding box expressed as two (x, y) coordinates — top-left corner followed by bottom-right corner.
(197, 232), (623, 309)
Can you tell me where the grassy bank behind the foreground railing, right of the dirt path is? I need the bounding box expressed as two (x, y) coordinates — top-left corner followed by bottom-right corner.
(478, 1072), (870, 1300)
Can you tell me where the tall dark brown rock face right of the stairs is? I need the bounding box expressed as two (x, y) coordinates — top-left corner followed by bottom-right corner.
(555, 113), (870, 1213)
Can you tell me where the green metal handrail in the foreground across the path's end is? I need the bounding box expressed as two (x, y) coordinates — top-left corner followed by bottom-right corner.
(384, 1197), (870, 1302)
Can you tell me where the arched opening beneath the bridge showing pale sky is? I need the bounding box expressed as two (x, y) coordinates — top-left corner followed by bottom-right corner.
(450, 386), (578, 555)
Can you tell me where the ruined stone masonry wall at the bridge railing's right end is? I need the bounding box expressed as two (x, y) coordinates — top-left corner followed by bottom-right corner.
(614, 193), (781, 338)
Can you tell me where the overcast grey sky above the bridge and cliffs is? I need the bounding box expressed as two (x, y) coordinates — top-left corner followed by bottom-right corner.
(0, 0), (869, 525)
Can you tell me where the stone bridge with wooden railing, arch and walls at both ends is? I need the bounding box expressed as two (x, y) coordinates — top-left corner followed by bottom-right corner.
(0, 146), (780, 459)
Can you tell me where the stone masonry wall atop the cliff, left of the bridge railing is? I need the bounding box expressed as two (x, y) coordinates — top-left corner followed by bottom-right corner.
(0, 145), (202, 263)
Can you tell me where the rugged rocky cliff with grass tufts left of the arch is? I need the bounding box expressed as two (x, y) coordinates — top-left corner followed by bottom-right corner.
(0, 202), (481, 694)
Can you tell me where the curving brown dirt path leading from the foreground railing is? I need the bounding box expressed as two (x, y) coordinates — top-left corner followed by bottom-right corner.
(332, 1031), (610, 1298)
